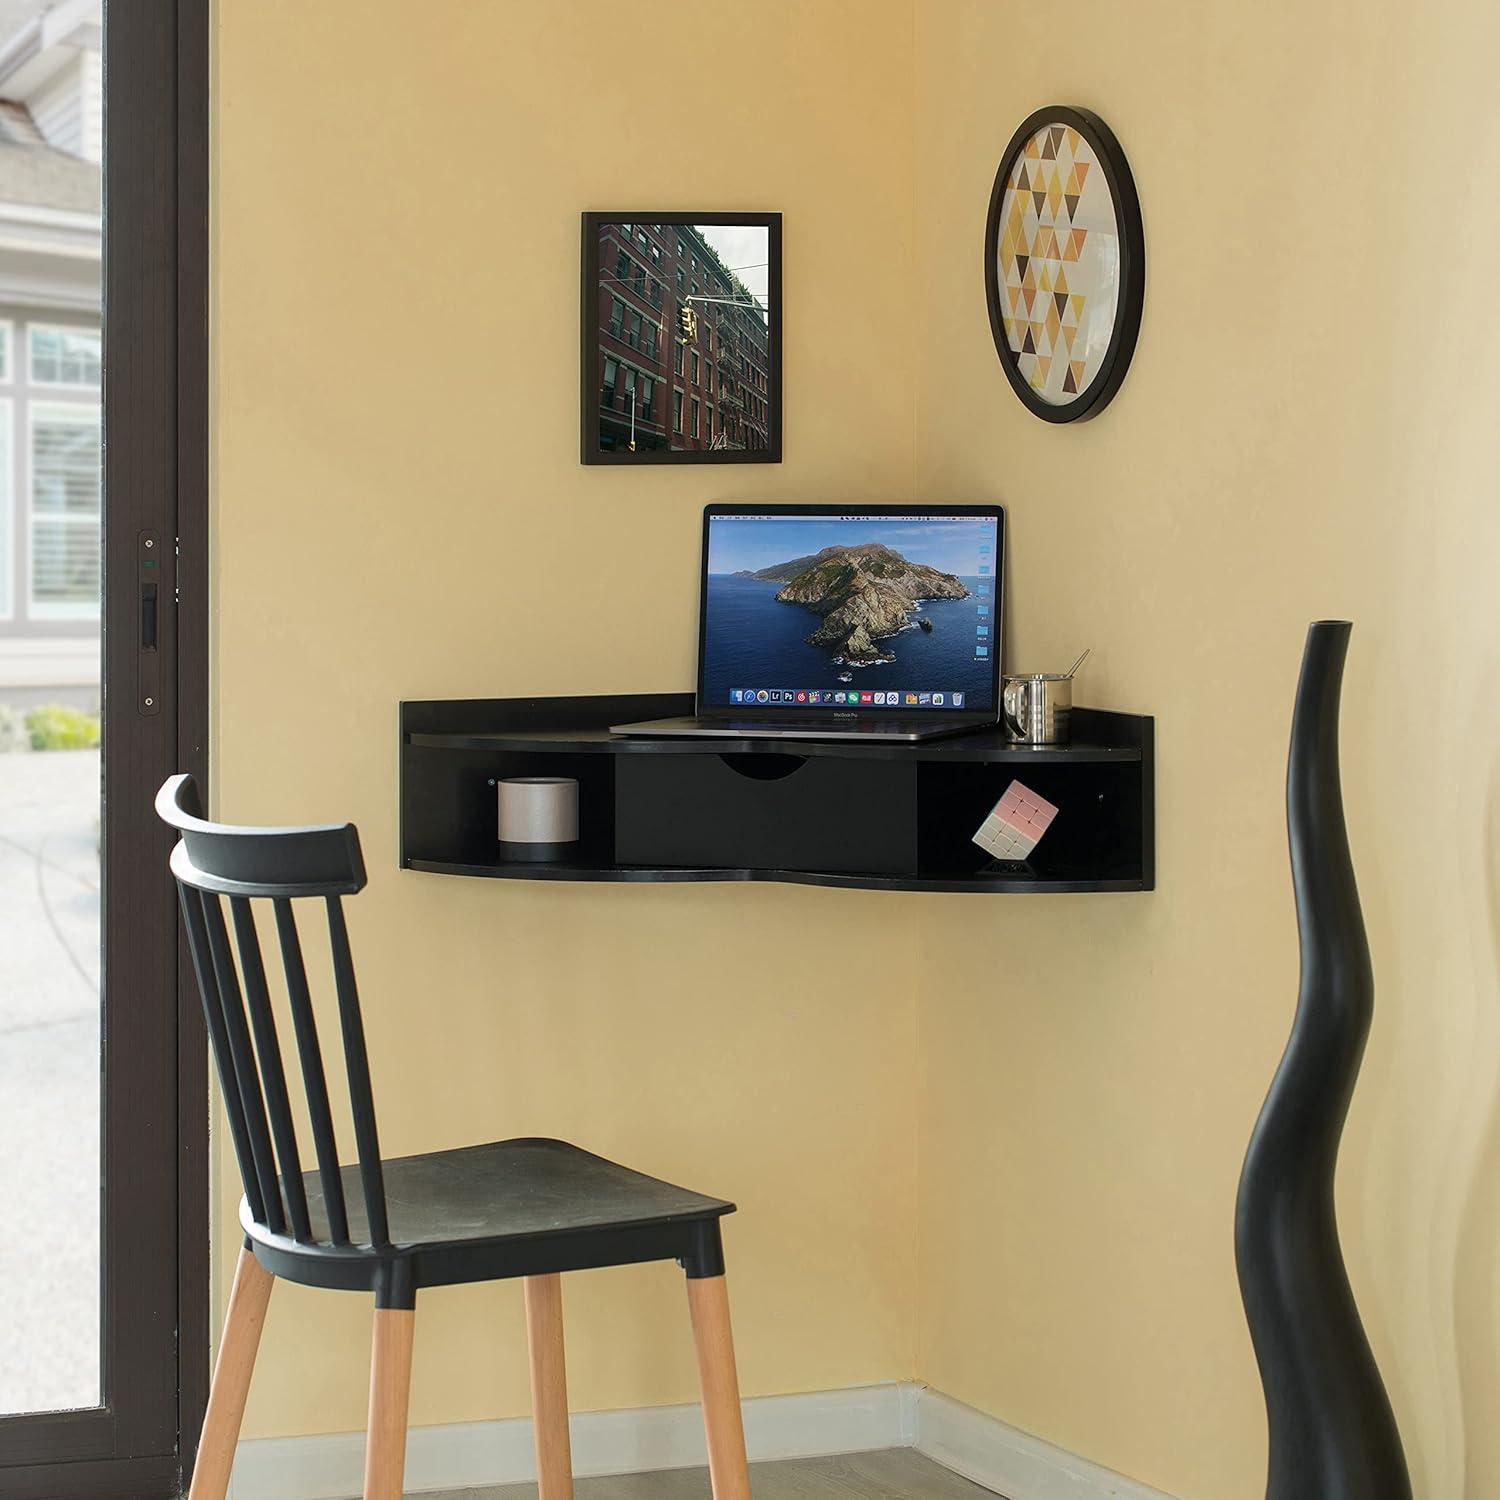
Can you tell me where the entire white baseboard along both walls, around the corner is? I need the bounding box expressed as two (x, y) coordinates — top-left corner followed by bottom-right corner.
(230, 1382), (1172, 1500)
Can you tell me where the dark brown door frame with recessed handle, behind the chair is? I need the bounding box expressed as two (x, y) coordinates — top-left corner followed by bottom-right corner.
(0, 0), (209, 1500)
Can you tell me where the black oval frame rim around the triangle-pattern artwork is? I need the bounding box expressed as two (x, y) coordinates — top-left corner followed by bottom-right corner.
(984, 105), (1146, 422)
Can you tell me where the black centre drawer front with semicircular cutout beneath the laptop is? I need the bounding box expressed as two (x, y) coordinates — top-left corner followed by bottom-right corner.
(615, 752), (917, 875)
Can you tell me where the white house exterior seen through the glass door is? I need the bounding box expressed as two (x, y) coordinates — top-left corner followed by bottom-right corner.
(0, 0), (104, 708)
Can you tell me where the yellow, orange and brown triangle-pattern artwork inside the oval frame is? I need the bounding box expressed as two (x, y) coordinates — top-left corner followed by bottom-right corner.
(996, 125), (1119, 407)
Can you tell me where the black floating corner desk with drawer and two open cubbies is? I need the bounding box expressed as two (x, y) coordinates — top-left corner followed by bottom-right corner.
(401, 693), (1155, 893)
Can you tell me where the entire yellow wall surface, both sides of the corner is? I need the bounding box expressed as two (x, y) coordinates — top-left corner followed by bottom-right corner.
(215, 0), (1500, 1500)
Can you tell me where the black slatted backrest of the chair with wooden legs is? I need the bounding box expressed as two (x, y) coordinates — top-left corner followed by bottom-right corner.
(156, 776), (390, 1247)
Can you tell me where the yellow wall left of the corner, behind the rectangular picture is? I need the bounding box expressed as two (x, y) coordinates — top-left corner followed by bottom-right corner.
(215, 0), (917, 1434)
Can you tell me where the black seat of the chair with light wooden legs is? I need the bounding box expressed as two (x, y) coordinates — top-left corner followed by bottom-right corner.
(242, 1139), (735, 1287)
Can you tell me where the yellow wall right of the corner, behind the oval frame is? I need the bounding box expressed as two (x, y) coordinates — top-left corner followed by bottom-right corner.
(915, 0), (1500, 1500)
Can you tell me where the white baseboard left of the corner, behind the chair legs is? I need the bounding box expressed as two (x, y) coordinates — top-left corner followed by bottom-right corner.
(230, 1382), (915, 1500)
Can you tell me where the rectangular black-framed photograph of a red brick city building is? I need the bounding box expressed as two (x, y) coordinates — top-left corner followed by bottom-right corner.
(582, 210), (782, 464)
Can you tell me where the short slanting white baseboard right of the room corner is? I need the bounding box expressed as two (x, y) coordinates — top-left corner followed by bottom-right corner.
(914, 1386), (1172, 1500)
